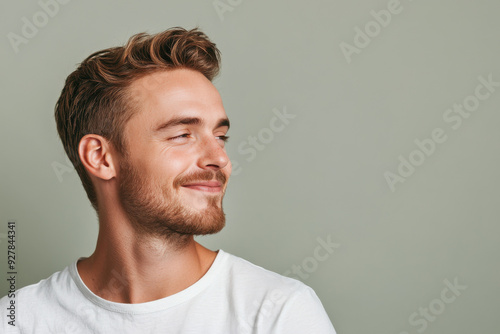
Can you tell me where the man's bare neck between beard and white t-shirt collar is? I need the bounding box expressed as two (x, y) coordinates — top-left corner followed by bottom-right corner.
(77, 205), (217, 303)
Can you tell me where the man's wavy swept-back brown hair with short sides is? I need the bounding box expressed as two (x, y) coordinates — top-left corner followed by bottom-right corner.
(55, 27), (220, 211)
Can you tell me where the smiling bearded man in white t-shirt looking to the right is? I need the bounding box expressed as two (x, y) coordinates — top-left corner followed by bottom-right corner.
(0, 28), (335, 334)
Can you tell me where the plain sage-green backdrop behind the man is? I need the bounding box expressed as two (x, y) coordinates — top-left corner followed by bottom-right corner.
(0, 0), (500, 334)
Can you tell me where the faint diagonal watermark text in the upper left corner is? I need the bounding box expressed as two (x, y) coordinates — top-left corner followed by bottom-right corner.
(7, 0), (71, 54)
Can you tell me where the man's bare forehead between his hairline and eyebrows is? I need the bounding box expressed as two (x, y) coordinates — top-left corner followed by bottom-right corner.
(128, 69), (226, 126)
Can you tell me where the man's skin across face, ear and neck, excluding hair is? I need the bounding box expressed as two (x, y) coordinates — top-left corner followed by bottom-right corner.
(77, 69), (231, 303)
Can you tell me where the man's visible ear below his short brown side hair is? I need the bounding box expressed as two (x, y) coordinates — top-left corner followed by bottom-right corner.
(78, 134), (117, 180)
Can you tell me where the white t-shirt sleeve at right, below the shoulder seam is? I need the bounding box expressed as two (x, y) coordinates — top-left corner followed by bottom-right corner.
(273, 286), (336, 334)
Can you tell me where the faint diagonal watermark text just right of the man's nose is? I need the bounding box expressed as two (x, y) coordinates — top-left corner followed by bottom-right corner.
(231, 106), (297, 175)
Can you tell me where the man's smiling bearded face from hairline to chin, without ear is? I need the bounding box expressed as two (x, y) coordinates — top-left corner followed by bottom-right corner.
(117, 69), (231, 245)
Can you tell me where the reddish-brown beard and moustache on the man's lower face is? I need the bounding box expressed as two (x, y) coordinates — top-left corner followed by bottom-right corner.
(118, 162), (227, 248)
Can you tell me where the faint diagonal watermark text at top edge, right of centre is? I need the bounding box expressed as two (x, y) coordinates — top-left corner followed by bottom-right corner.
(339, 0), (413, 64)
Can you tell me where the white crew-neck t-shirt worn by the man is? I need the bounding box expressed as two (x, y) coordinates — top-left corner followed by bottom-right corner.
(0, 250), (335, 334)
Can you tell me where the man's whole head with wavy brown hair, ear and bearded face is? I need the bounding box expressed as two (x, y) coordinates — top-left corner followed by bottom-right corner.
(55, 28), (231, 240)
